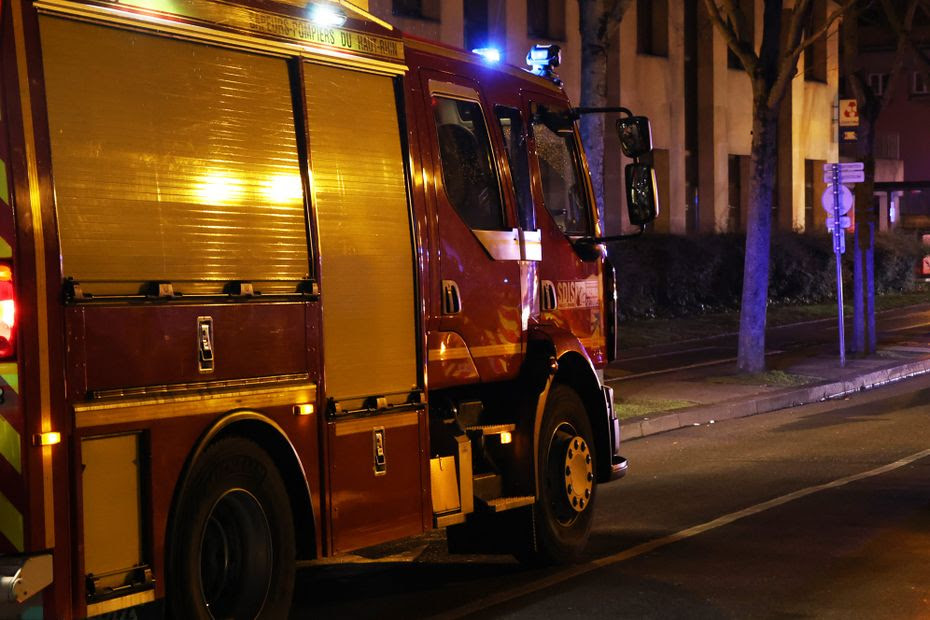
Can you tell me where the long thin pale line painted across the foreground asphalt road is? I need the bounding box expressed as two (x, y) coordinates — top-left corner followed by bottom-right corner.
(433, 449), (930, 618)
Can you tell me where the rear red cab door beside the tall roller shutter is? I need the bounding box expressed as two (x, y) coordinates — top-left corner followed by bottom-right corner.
(421, 71), (523, 387)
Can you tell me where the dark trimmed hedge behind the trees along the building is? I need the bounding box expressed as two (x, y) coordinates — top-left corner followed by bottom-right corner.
(610, 232), (923, 319)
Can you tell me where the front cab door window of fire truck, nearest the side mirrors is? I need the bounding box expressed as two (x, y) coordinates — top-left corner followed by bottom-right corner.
(533, 110), (591, 236)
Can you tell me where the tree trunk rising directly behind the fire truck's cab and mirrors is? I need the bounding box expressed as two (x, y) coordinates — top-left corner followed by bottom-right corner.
(578, 0), (633, 221)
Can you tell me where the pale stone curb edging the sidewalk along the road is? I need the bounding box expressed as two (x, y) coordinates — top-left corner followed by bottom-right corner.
(620, 359), (930, 440)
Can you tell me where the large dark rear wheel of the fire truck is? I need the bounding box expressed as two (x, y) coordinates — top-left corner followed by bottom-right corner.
(167, 437), (295, 620)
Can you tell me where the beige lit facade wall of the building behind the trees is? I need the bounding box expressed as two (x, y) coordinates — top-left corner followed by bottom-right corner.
(369, 0), (840, 234)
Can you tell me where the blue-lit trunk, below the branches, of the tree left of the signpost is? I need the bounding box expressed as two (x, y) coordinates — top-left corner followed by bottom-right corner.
(737, 101), (778, 372)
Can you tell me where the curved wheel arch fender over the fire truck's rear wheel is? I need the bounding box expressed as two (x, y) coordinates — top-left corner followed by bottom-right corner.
(166, 410), (318, 558)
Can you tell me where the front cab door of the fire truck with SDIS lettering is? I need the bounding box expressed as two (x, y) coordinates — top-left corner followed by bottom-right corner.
(524, 93), (607, 367)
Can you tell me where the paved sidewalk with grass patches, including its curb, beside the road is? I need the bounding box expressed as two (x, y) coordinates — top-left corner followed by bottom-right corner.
(605, 338), (930, 440)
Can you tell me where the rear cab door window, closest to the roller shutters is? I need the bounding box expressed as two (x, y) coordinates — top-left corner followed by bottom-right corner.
(433, 96), (505, 230)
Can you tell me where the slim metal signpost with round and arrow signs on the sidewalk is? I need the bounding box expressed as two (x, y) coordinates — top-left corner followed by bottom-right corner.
(820, 162), (865, 366)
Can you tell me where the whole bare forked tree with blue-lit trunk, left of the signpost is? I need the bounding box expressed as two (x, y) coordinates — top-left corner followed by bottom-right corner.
(704, 0), (855, 372)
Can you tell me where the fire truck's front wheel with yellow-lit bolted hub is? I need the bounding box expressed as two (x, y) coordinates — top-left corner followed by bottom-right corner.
(518, 384), (597, 565)
